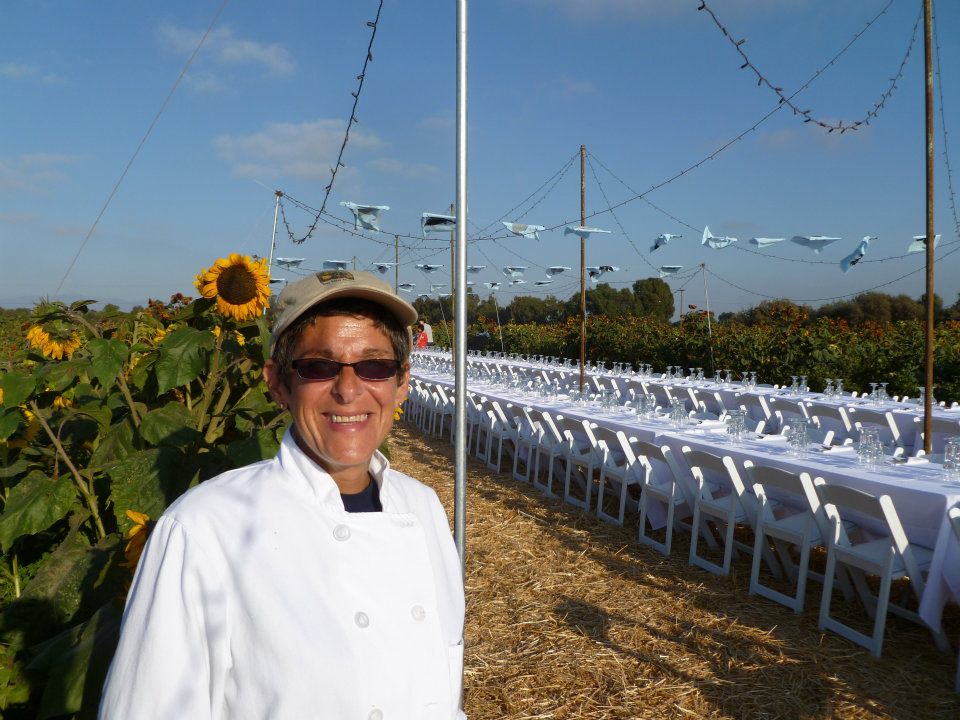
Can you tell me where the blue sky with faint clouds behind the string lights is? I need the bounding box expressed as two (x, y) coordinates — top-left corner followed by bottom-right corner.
(0, 0), (960, 313)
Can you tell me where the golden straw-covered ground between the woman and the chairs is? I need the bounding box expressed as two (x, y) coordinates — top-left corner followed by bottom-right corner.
(391, 424), (960, 720)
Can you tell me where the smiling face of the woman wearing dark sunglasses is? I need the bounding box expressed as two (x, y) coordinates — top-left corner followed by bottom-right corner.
(264, 315), (410, 491)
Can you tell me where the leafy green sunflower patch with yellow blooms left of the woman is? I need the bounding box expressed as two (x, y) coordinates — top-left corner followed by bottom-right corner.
(0, 255), (286, 717)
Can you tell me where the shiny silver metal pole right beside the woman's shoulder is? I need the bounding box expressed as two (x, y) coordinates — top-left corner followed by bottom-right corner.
(453, 0), (467, 580)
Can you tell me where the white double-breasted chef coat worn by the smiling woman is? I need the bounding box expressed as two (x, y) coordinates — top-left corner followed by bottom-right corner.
(99, 431), (465, 720)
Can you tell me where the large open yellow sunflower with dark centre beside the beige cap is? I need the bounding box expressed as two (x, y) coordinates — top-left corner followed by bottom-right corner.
(195, 253), (270, 321)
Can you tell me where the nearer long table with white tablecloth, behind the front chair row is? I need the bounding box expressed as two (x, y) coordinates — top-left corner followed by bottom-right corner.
(414, 371), (960, 631)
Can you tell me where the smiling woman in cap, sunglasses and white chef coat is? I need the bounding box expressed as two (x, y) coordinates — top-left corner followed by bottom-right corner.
(100, 270), (464, 720)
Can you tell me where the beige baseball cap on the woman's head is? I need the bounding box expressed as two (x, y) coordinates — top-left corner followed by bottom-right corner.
(271, 270), (417, 347)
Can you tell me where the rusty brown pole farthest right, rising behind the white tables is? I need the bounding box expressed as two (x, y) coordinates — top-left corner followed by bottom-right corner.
(923, 0), (935, 453)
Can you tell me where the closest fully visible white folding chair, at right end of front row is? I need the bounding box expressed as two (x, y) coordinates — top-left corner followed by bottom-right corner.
(814, 478), (949, 657)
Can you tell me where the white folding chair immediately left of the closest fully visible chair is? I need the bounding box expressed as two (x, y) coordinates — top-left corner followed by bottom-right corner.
(743, 460), (823, 613)
